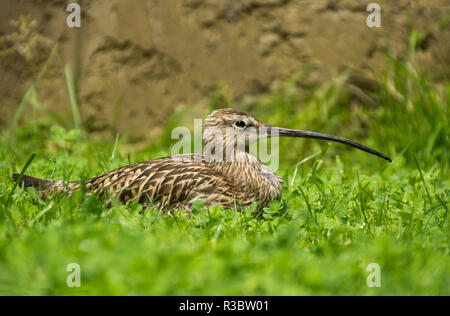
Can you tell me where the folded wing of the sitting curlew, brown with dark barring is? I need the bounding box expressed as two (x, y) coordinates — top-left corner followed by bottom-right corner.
(86, 154), (233, 207)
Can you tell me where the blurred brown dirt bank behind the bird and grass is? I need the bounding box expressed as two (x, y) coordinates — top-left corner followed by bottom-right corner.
(0, 0), (450, 139)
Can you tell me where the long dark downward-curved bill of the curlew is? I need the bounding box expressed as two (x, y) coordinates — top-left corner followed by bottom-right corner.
(266, 125), (392, 162)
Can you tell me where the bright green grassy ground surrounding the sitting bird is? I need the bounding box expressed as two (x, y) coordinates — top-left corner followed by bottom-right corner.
(0, 43), (450, 295)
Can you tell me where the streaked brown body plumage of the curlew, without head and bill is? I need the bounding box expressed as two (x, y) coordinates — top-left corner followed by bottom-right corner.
(22, 153), (283, 211)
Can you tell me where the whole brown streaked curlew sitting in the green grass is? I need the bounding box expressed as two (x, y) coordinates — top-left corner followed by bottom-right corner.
(13, 109), (391, 212)
